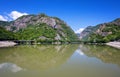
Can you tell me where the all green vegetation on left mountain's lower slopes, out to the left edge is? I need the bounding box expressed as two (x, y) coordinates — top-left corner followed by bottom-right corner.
(0, 23), (78, 43)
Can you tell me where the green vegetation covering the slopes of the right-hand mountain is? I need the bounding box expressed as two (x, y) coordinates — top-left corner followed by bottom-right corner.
(89, 24), (120, 43)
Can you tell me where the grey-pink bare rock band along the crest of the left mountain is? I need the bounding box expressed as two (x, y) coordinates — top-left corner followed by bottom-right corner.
(7, 14), (64, 31)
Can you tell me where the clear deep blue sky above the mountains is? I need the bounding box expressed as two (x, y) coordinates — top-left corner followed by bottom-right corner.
(0, 0), (120, 31)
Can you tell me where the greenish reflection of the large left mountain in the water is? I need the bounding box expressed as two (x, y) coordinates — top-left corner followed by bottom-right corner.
(0, 45), (78, 70)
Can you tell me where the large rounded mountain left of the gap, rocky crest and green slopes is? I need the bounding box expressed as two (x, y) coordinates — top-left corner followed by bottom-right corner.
(0, 14), (78, 42)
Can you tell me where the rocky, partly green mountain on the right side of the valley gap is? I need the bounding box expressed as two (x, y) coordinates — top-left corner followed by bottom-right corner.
(80, 18), (120, 43)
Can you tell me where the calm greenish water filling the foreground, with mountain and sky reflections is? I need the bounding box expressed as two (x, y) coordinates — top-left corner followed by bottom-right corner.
(0, 44), (120, 77)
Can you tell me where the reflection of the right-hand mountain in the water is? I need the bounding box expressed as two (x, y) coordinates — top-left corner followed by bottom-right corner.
(79, 45), (120, 66)
